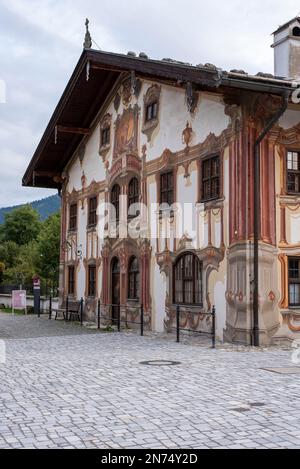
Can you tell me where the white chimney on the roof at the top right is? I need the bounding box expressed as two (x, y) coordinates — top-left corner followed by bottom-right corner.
(272, 16), (300, 80)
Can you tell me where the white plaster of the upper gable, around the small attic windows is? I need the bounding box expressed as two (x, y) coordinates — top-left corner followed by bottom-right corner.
(67, 81), (230, 192)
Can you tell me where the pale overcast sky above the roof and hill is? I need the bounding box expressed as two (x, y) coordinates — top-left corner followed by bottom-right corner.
(0, 0), (300, 207)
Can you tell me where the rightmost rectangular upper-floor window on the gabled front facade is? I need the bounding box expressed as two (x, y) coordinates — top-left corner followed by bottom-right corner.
(202, 156), (220, 202)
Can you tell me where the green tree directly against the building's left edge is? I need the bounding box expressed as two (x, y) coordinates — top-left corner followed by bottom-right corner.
(35, 213), (60, 285)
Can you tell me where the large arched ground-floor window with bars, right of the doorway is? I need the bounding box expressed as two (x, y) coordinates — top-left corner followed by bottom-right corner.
(173, 253), (203, 306)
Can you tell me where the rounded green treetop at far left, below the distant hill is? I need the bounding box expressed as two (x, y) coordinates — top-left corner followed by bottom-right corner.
(1, 205), (41, 246)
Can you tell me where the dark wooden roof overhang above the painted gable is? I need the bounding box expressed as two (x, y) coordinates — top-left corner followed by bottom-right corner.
(23, 49), (221, 189)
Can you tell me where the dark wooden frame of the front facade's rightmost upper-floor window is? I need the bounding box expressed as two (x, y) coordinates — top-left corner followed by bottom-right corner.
(200, 154), (222, 203)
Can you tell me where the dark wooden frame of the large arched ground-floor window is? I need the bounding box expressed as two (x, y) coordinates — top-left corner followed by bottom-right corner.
(173, 251), (203, 308)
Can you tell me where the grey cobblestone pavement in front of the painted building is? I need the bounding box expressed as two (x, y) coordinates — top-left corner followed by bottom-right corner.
(0, 314), (300, 449)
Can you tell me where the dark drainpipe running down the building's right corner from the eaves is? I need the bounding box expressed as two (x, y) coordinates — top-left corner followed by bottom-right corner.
(253, 91), (291, 347)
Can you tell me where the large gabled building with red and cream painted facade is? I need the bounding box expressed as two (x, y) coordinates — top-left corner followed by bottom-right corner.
(23, 18), (300, 345)
